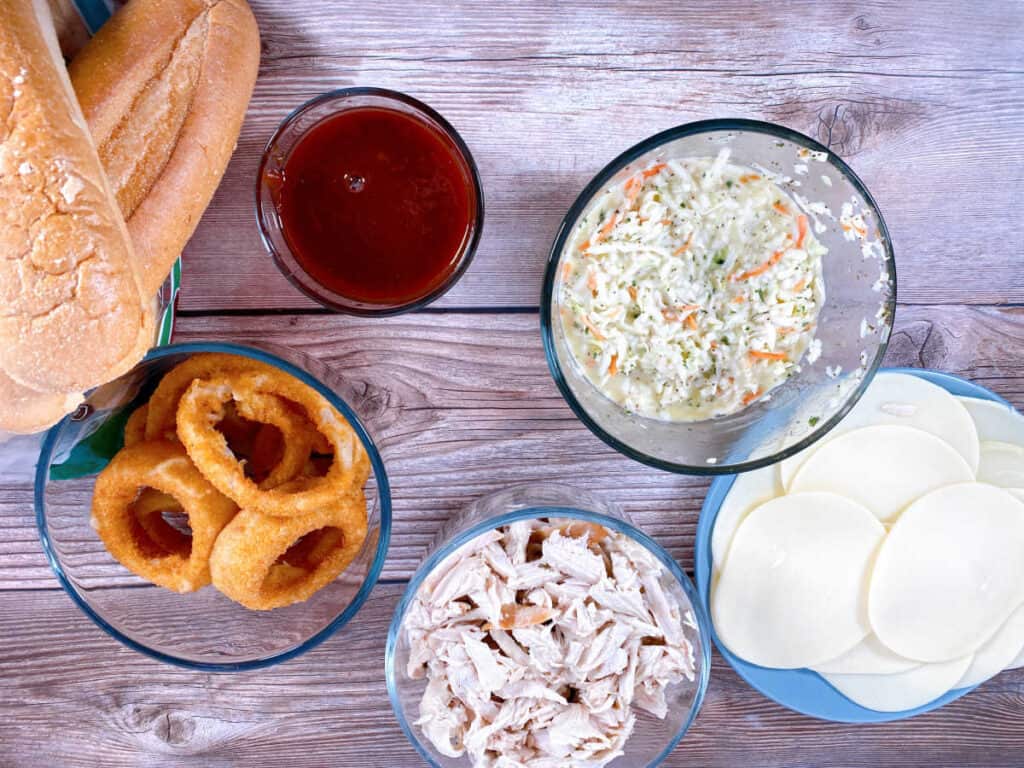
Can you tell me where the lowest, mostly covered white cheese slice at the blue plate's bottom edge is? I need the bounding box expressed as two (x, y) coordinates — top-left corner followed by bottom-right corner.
(822, 655), (971, 712)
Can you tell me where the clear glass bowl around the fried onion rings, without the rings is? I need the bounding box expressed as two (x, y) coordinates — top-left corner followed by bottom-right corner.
(35, 343), (391, 672)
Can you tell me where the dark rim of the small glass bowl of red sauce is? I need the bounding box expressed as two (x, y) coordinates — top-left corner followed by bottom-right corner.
(254, 86), (484, 317)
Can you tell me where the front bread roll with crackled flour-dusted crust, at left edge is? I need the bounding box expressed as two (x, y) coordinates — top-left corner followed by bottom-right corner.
(0, 0), (154, 397)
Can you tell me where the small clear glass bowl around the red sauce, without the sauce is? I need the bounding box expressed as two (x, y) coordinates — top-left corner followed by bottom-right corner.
(256, 88), (483, 316)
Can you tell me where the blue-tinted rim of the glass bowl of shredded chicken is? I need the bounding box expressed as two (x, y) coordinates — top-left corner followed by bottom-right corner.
(384, 504), (712, 768)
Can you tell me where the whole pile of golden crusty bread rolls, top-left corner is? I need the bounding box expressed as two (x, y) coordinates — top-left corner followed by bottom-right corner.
(0, 0), (259, 436)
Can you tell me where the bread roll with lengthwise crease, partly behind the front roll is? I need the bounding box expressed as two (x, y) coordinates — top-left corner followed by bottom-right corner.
(70, 0), (259, 295)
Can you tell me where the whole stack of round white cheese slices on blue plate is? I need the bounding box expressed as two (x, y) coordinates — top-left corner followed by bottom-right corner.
(711, 373), (1024, 712)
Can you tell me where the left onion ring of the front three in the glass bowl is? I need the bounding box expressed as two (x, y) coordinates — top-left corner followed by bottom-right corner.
(92, 440), (238, 592)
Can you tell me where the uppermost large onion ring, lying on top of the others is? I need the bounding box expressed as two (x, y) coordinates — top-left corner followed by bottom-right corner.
(178, 370), (370, 517)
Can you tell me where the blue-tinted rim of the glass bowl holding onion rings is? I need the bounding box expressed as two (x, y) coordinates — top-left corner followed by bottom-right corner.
(33, 342), (391, 672)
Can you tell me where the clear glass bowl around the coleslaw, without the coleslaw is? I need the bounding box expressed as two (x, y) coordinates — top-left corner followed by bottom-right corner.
(541, 120), (896, 475)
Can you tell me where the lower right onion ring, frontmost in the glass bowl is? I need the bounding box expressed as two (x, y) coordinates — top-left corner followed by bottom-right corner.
(210, 493), (367, 610)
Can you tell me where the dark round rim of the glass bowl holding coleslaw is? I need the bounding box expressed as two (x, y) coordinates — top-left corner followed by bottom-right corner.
(541, 118), (897, 476)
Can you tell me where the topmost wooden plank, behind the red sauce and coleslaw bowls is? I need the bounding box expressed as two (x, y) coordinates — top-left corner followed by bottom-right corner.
(181, 0), (1024, 311)
